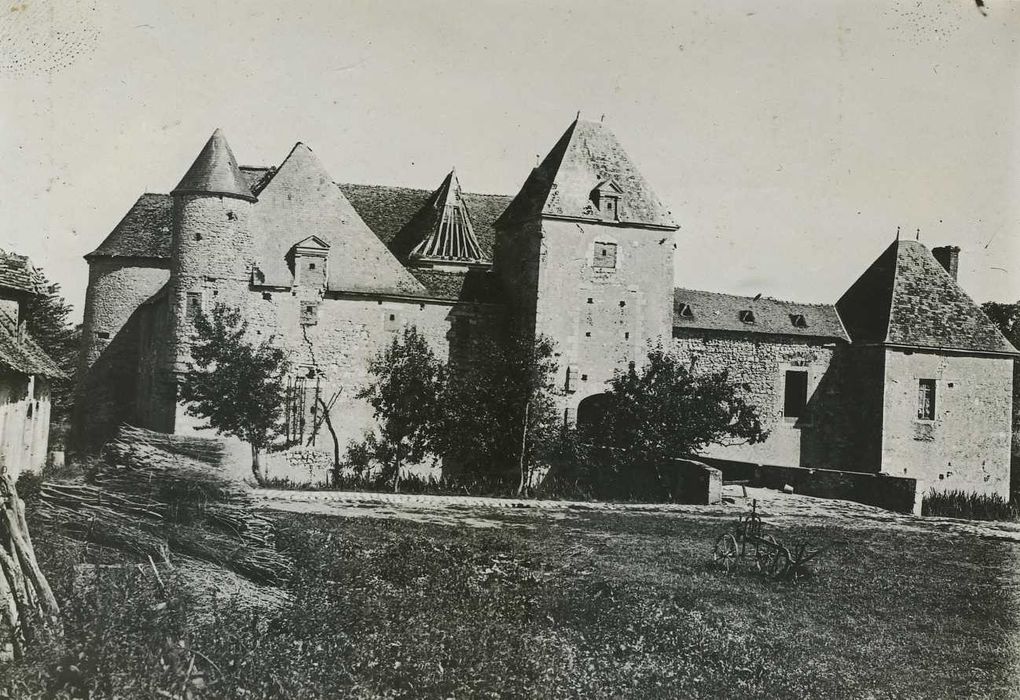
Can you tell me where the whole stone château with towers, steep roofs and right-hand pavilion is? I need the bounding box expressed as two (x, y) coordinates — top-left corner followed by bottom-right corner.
(74, 119), (1017, 495)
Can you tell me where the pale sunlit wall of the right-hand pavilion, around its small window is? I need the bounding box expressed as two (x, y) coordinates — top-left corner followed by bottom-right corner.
(881, 349), (1013, 498)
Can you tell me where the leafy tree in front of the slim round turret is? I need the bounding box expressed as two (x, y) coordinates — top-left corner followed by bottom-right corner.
(179, 304), (289, 482)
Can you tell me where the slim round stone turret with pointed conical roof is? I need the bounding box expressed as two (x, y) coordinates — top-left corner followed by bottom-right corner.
(167, 129), (255, 371)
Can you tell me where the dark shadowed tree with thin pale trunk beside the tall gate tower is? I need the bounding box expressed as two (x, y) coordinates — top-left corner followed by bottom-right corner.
(436, 335), (563, 494)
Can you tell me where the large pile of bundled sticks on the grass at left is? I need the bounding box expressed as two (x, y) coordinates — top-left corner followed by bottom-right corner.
(39, 426), (291, 585)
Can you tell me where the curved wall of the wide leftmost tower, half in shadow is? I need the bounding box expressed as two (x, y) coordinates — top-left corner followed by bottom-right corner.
(71, 258), (169, 449)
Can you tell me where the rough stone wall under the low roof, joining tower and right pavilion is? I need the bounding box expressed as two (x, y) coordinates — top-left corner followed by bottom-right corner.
(671, 328), (854, 467)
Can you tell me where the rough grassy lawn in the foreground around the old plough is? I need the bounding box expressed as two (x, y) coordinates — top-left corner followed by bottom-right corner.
(0, 512), (1020, 698)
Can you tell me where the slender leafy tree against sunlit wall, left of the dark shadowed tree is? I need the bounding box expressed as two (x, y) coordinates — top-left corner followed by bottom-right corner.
(357, 326), (446, 492)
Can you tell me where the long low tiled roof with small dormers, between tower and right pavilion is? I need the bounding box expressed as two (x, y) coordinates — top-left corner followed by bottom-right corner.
(673, 289), (849, 340)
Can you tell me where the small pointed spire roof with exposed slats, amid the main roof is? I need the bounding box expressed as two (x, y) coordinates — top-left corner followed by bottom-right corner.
(410, 170), (482, 263)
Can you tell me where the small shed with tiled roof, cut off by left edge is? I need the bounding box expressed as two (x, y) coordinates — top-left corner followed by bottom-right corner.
(0, 250), (65, 479)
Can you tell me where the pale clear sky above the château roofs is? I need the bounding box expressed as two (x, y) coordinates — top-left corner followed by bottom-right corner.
(0, 0), (1020, 324)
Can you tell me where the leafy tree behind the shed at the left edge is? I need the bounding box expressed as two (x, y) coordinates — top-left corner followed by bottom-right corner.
(24, 267), (82, 424)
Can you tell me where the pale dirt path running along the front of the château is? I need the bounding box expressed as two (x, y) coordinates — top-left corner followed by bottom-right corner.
(256, 487), (1020, 543)
